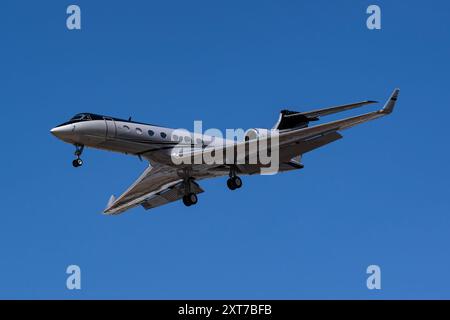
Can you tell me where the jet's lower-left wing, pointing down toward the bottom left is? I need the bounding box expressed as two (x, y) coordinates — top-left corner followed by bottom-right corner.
(104, 164), (203, 215)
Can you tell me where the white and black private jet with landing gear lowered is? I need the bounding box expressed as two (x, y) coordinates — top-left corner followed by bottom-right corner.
(50, 89), (399, 215)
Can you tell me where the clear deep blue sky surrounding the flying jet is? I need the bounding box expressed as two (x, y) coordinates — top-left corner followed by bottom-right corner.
(0, 0), (450, 299)
